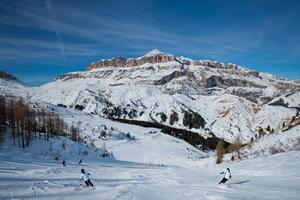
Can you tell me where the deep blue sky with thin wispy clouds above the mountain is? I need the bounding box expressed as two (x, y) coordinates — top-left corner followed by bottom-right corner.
(0, 0), (300, 85)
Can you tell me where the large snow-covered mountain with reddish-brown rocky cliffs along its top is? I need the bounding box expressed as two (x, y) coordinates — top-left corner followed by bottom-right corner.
(18, 50), (300, 143)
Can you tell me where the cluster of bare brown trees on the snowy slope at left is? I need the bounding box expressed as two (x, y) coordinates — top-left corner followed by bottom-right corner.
(0, 95), (79, 148)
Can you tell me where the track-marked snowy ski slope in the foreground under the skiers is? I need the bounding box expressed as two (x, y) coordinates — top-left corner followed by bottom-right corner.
(0, 152), (300, 200)
